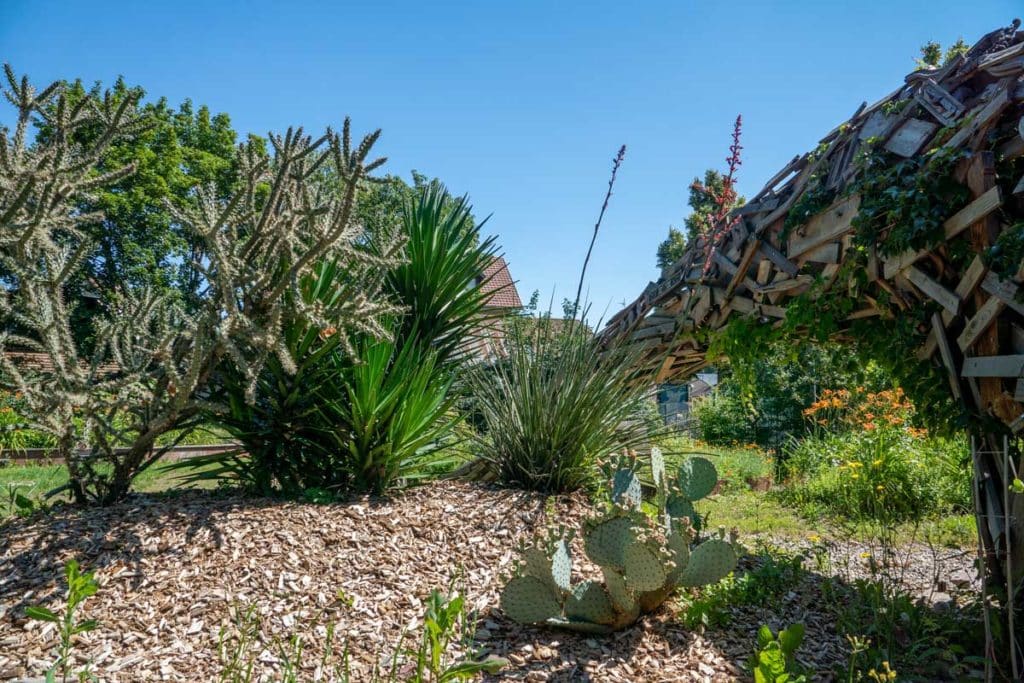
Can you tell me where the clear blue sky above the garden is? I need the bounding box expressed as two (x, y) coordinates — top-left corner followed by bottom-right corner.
(0, 0), (1024, 321)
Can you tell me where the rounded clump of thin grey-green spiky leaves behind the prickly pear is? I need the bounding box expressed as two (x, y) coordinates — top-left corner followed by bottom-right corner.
(469, 316), (649, 493)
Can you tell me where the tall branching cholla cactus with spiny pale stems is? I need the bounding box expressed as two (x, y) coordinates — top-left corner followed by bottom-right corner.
(0, 67), (397, 504)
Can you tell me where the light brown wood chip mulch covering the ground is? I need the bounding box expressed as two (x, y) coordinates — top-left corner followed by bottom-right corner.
(0, 482), (974, 681)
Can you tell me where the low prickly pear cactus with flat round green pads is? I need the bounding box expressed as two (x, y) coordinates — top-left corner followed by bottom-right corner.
(501, 449), (736, 633)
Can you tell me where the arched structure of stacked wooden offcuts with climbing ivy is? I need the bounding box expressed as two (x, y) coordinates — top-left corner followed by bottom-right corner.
(602, 20), (1024, 678)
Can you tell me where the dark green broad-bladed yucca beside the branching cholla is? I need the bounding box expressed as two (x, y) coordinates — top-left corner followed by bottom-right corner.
(188, 183), (495, 496)
